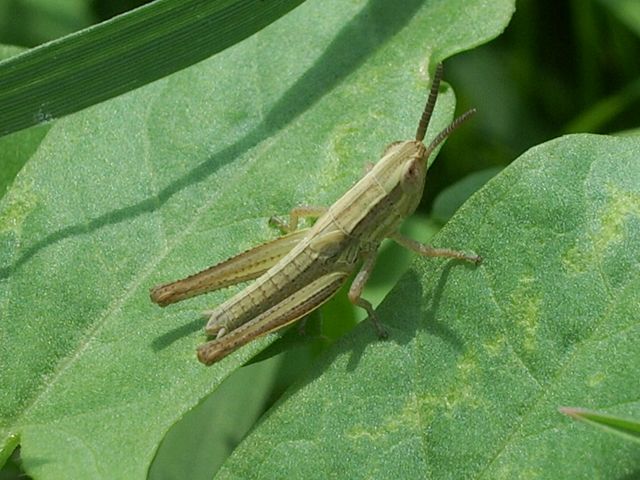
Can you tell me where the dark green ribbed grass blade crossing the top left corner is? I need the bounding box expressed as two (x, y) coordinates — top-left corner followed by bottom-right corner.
(0, 0), (310, 136)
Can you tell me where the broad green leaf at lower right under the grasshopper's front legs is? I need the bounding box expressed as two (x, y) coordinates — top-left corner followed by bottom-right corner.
(217, 135), (640, 479)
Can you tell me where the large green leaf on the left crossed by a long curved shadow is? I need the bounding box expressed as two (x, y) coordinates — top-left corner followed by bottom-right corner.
(0, 0), (513, 479)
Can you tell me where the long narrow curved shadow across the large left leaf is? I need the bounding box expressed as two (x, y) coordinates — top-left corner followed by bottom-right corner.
(0, 0), (426, 279)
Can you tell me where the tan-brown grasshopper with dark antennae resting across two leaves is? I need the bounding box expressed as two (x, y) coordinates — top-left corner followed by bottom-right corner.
(150, 64), (481, 365)
